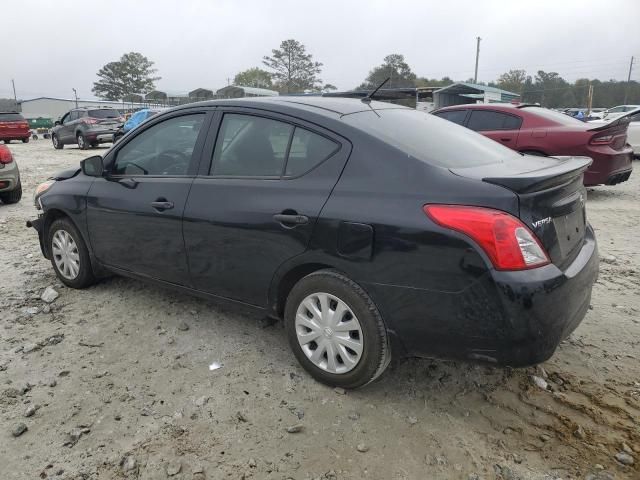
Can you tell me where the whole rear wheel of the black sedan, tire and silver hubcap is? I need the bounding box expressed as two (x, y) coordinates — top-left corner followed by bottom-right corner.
(285, 270), (391, 388)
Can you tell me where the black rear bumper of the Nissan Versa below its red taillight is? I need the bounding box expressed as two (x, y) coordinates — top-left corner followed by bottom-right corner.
(364, 226), (599, 367)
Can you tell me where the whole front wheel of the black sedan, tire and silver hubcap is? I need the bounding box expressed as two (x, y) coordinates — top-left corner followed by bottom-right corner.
(47, 218), (95, 288)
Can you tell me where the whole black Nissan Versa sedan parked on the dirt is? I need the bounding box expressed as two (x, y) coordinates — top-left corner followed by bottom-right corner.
(28, 97), (598, 388)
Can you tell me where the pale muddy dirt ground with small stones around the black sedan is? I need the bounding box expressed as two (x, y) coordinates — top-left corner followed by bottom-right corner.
(0, 140), (640, 480)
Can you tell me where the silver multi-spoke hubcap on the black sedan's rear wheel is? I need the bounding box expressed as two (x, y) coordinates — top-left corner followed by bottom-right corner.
(295, 293), (363, 374)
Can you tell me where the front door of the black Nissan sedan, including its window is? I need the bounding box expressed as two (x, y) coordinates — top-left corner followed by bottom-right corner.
(87, 112), (206, 285)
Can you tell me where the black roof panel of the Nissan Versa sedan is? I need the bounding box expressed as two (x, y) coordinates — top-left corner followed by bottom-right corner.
(166, 95), (408, 117)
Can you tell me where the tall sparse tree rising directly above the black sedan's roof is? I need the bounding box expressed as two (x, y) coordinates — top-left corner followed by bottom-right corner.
(262, 39), (322, 93)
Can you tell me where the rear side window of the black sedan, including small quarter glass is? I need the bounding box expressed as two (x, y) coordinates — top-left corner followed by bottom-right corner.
(210, 113), (339, 178)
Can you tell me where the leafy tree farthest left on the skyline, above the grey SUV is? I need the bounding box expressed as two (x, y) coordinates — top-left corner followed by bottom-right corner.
(92, 52), (161, 100)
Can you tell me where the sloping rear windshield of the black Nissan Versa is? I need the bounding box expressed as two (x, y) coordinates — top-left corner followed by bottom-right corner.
(342, 108), (518, 168)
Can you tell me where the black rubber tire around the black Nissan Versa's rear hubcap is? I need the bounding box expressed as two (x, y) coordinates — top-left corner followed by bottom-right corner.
(284, 270), (391, 388)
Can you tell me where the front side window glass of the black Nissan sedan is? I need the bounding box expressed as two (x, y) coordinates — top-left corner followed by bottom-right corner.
(112, 113), (204, 176)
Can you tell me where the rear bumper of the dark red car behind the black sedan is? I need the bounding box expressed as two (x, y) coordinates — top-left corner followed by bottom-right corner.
(584, 147), (633, 186)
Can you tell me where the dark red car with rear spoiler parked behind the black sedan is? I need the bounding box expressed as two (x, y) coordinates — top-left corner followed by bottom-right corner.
(433, 103), (633, 185)
